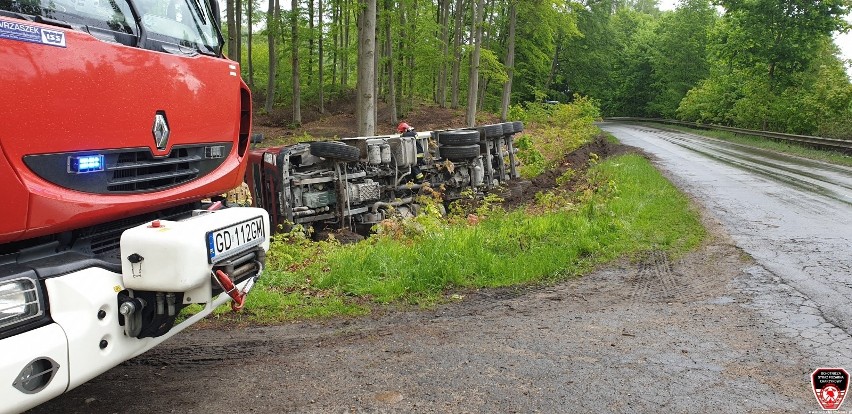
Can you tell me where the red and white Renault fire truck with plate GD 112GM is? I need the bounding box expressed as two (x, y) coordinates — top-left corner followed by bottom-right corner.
(0, 0), (270, 412)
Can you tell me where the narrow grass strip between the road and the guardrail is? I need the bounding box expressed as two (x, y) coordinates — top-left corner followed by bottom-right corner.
(649, 123), (852, 167)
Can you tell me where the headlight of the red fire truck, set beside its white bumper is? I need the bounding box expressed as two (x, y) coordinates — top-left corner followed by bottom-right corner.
(0, 277), (44, 330)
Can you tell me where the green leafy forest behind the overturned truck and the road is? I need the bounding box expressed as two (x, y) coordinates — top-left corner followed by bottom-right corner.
(223, 0), (852, 139)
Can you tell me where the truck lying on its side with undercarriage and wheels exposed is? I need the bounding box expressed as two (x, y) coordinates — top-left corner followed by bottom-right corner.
(246, 122), (523, 232)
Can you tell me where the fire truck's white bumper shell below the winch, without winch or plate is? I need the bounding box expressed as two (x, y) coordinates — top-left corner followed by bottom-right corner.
(0, 268), (260, 413)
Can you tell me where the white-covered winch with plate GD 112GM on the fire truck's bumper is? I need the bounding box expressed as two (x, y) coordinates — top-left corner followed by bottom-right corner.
(118, 208), (270, 338)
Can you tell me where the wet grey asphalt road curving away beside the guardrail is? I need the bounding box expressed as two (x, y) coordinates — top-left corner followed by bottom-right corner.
(601, 123), (852, 363)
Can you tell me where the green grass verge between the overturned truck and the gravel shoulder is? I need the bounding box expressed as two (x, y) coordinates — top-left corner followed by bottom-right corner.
(196, 155), (705, 323)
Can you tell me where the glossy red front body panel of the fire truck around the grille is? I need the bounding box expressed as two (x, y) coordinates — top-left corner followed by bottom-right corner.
(0, 17), (251, 243)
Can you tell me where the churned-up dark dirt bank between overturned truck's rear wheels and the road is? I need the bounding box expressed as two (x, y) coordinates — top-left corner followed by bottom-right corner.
(499, 134), (635, 210)
